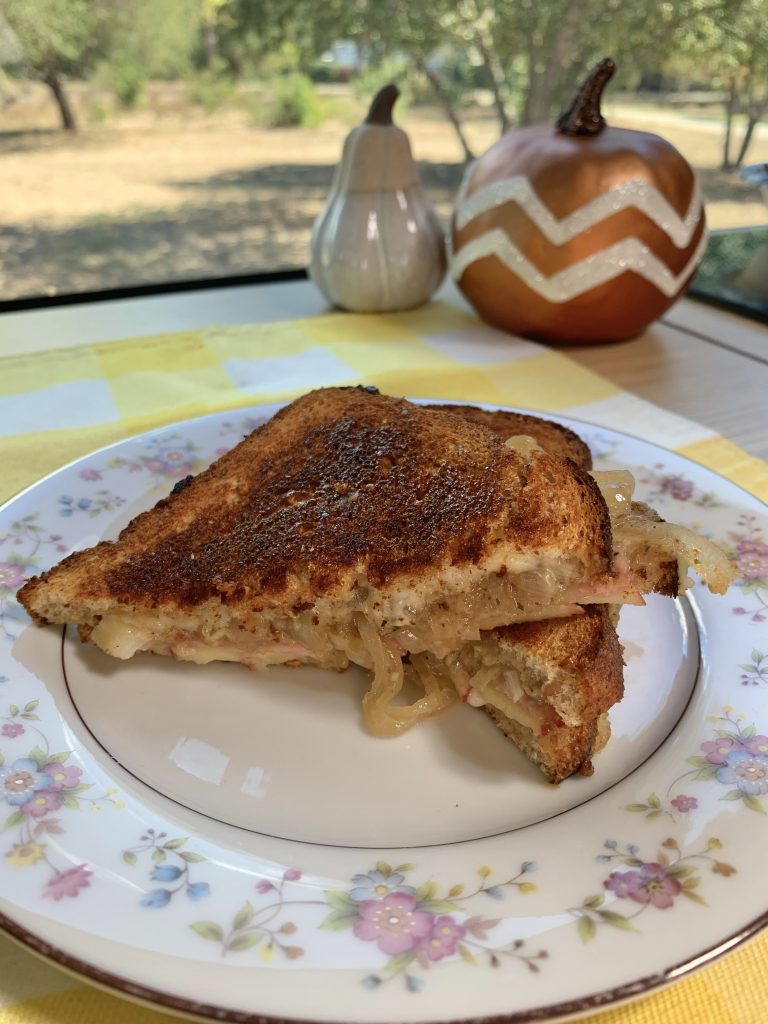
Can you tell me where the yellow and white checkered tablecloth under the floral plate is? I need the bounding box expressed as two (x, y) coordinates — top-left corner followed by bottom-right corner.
(0, 303), (768, 1024)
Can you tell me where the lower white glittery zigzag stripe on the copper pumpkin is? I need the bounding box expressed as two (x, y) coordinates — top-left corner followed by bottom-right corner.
(451, 227), (708, 302)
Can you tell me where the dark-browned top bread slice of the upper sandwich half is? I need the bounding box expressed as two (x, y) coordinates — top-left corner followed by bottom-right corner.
(18, 388), (612, 623)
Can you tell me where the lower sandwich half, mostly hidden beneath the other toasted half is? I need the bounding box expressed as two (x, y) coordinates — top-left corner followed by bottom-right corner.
(423, 406), (730, 783)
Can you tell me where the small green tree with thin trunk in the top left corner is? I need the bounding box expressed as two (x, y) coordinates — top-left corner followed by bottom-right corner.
(0, 0), (109, 131)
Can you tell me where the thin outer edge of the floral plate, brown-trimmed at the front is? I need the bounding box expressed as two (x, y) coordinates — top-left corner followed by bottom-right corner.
(0, 395), (768, 1024)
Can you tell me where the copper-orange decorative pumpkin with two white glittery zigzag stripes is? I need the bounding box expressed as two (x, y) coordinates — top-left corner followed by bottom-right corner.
(452, 58), (707, 342)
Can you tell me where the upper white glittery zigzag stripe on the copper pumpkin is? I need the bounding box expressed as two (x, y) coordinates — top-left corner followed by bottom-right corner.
(456, 172), (702, 249)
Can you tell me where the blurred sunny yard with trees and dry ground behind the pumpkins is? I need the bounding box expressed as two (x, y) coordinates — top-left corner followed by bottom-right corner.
(0, 0), (768, 299)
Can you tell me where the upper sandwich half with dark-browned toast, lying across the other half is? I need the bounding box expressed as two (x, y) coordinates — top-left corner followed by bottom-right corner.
(18, 388), (612, 668)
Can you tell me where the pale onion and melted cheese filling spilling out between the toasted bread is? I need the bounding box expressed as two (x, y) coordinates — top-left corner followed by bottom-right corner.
(80, 472), (732, 735)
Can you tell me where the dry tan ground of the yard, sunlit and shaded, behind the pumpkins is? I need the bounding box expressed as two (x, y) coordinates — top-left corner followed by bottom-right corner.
(0, 81), (768, 299)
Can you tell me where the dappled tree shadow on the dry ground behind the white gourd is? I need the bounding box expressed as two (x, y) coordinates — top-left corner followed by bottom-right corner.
(0, 157), (463, 299)
